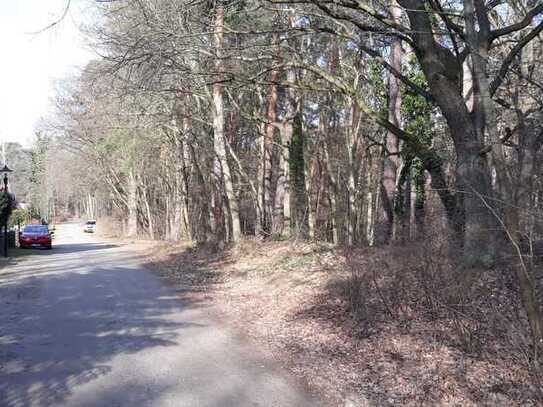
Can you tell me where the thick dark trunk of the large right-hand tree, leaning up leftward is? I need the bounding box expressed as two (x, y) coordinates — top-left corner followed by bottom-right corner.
(399, 0), (494, 255)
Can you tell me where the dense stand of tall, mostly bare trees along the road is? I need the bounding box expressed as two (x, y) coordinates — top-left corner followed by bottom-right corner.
(13, 0), (543, 404)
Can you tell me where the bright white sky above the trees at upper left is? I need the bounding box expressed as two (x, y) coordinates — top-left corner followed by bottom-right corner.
(0, 0), (93, 146)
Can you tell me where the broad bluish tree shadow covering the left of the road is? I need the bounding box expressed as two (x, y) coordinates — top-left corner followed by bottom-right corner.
(0, 244), (208, 407)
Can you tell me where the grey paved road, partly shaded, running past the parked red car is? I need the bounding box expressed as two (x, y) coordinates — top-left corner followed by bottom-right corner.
(0, 224), (318, 407)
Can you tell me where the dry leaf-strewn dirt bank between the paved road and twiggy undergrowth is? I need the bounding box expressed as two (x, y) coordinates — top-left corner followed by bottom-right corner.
(141, 241), (543, 406)
